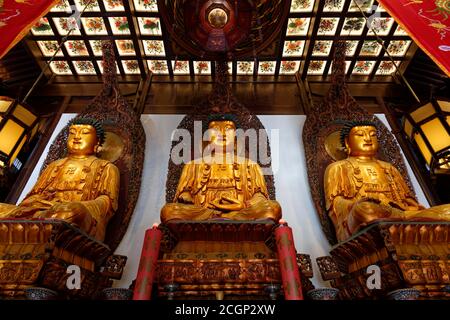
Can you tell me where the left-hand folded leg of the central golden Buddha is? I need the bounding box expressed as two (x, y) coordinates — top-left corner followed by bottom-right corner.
(161, 203), (221, 223)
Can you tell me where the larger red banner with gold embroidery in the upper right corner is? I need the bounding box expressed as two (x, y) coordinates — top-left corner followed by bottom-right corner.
(378, 0), (450, 76)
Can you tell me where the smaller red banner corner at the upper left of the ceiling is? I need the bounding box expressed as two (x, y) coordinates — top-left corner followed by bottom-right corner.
(0, 0), (58, 59)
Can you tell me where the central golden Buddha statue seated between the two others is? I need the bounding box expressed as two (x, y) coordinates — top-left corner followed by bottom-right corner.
(161, 115), (281, 223)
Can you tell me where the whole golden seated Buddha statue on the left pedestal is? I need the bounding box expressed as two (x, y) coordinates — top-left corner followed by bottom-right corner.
(0, 118), (120, 241)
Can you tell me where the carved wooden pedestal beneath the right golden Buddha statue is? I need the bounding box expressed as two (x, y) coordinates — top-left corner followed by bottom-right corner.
(317, 222), (450, 299)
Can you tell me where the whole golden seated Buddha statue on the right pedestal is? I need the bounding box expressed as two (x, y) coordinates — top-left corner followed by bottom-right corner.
(324, 121), (450, 241)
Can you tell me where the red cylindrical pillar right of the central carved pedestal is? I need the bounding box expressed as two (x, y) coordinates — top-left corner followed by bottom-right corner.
(275, 223), (303, 300)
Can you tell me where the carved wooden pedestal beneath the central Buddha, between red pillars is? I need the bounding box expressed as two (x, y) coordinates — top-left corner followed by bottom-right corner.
(156, 221), (312, 299)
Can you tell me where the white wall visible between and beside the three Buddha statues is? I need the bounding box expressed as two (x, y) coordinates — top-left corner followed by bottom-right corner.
(17, 114), (427, 287)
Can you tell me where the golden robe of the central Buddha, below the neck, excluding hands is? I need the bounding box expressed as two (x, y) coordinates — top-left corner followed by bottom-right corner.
(161, 159), (281, 222)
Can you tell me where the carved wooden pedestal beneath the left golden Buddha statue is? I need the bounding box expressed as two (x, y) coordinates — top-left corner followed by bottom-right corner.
(0, 219), (126, 299)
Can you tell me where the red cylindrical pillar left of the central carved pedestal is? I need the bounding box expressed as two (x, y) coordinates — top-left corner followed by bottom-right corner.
(133, 225), (162, 300)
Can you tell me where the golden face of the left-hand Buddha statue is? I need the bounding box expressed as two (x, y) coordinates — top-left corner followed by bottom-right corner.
(67, 124), (98, 155)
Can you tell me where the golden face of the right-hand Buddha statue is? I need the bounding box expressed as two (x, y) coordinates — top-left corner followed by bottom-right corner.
(346, 126), (378, 156)
